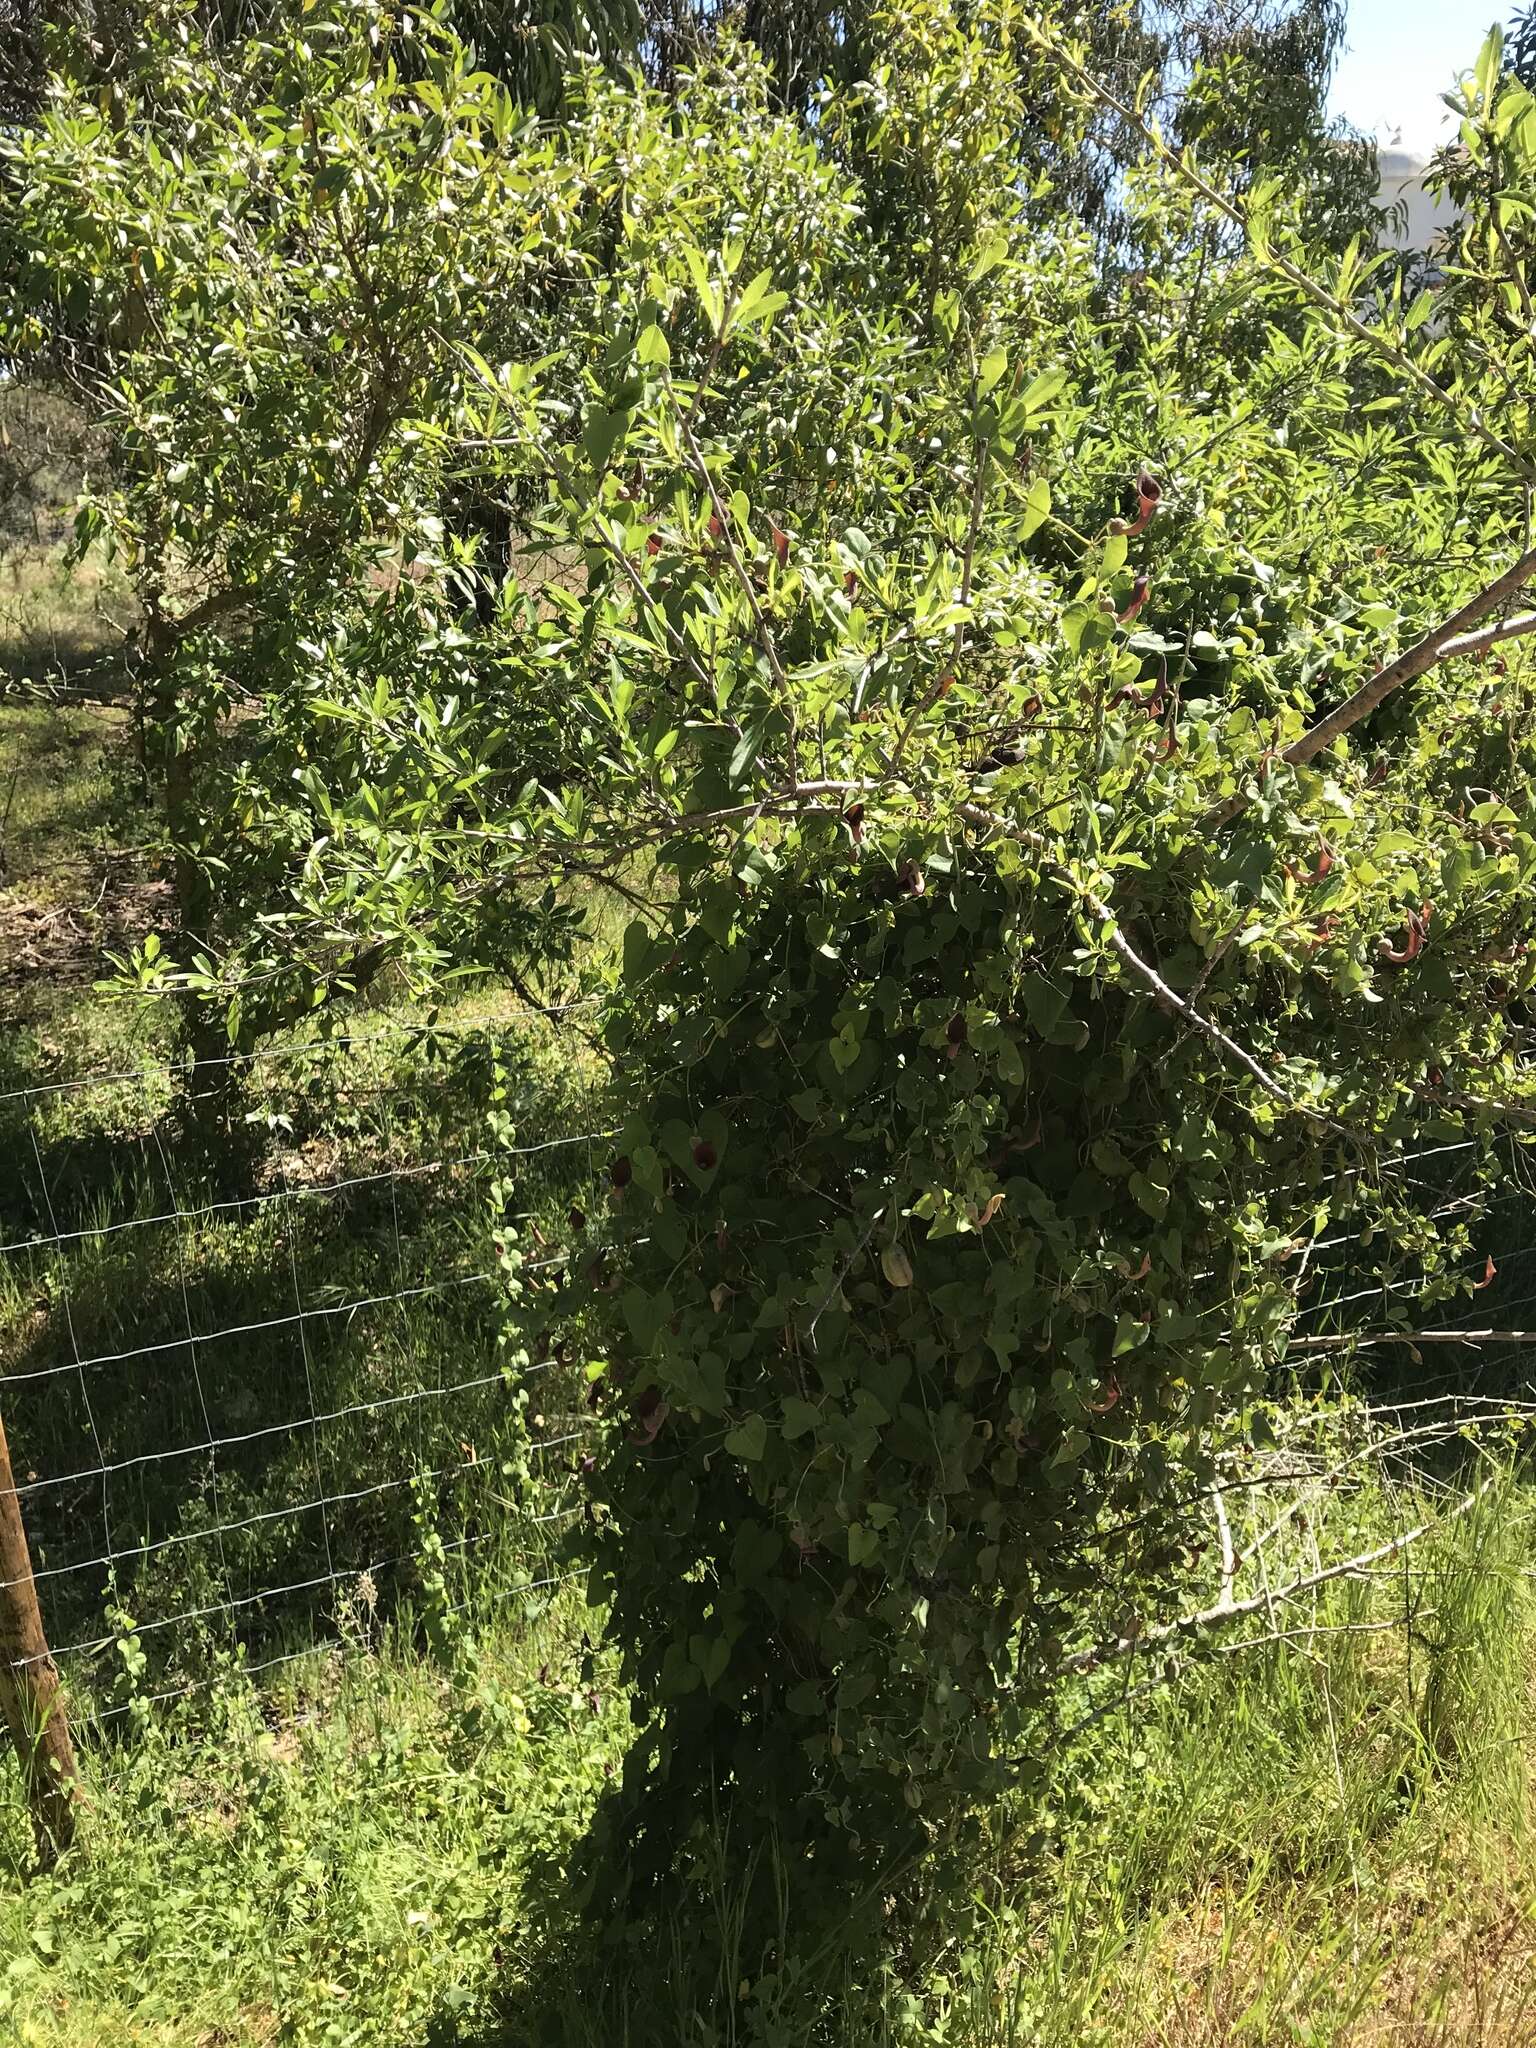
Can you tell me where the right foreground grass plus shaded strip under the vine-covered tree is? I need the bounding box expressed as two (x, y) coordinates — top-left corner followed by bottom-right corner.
(487, 1470), (1536, 2048)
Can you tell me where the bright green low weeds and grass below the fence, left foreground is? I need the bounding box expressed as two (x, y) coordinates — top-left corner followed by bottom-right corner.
(0, 1581), (621, 2048)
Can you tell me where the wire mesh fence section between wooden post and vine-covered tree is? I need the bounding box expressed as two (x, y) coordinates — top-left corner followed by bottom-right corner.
(0, 1012), (606, 1718)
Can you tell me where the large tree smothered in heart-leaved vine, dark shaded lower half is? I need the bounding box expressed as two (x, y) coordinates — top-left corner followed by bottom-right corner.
(487, 8), (1536, 1982)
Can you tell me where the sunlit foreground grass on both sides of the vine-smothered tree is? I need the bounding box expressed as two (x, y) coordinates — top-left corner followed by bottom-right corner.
(0, 1449), (1536, 2048)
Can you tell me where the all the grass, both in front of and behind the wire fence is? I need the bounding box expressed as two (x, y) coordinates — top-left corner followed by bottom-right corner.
(0, 524), (1536, 2048)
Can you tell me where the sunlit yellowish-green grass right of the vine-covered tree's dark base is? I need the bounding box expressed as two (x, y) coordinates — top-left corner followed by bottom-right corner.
(1034, 1481), (1536, 2048)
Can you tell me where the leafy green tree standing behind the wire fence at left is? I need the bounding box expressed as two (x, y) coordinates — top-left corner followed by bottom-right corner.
(0, 6), (626, 1044)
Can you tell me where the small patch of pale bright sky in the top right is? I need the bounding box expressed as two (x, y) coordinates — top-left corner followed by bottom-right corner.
(1329, 0), (1511, 156)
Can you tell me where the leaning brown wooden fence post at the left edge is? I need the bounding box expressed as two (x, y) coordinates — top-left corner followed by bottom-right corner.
(0, 1419), (80, 1868)
